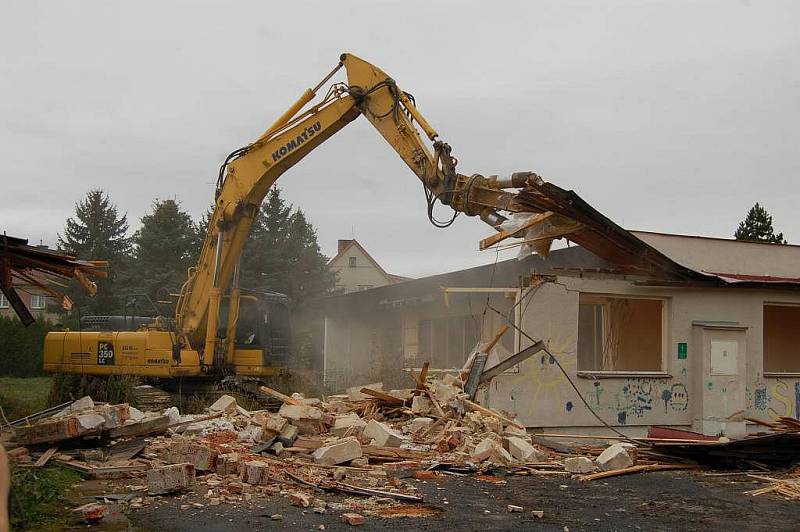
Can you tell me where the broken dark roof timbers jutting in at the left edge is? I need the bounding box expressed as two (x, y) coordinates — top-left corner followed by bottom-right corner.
(0, 235), (108, 326)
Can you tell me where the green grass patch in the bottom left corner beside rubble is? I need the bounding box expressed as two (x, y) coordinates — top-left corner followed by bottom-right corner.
(9, 466), (81, 530)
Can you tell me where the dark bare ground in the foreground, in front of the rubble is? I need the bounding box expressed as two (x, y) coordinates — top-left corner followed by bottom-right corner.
(72, 472), (800, 532)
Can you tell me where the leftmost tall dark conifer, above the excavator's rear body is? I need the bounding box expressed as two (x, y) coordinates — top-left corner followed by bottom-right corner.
(58, 189), (131, 314)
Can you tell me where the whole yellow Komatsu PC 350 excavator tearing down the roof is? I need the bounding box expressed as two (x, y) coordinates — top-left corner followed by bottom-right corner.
(44, 54), (533, 388)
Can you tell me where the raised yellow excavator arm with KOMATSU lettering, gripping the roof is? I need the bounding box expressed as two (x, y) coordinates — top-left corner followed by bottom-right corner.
(176, 54), (531, 367)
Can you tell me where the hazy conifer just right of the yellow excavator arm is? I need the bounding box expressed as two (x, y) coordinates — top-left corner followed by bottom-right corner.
(240, 188), (335, 307)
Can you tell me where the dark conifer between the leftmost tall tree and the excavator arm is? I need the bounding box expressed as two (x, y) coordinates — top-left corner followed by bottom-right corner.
(133, 199), (200, 308)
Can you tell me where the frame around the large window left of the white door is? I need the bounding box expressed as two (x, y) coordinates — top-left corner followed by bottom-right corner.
(575, 292), (672, 379)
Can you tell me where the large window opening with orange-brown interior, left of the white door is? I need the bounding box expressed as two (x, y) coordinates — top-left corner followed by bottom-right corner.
(578, 294), (665, 372)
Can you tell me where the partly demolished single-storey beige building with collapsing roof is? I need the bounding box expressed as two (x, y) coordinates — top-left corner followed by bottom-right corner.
(324, 183), (800, 437)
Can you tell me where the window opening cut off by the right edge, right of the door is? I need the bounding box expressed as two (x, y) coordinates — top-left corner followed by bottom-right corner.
(764, 305), (800, 373)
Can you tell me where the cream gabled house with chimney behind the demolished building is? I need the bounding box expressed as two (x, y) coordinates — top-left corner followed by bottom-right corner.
(328, 239), (408, 293)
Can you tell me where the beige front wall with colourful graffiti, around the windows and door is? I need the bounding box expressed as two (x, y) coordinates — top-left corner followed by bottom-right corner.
(484, 277), (800, 433)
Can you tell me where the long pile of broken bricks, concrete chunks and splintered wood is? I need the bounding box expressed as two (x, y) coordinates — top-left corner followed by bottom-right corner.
(4, 365), (720, 525)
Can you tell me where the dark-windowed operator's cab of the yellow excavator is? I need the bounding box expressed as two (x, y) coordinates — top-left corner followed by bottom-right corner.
(217, 289), (292, 376)
